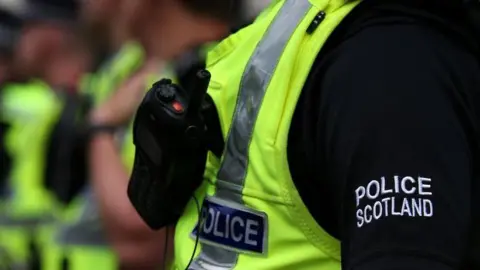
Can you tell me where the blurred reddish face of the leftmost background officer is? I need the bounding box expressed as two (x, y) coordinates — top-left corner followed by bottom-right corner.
(14, 23), (90, 87)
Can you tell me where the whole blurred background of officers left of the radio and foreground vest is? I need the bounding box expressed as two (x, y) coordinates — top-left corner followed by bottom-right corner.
(0, 0), (269, 270)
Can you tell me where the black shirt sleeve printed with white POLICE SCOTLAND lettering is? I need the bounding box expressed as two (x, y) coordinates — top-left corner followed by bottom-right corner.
(308, 14), (480, 270)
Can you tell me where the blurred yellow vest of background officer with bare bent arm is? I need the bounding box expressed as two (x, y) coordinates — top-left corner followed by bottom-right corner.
(42, 42), (144, 270)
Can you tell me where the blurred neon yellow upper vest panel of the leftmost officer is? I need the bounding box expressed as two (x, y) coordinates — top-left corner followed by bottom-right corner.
(2, 82), (62, 218)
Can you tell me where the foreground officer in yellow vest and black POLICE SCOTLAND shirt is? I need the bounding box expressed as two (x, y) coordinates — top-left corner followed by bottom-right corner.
(126, 0), (480, 270)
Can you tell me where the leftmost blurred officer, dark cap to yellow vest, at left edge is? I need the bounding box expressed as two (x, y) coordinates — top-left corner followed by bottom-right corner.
(0, 0), (90, 269)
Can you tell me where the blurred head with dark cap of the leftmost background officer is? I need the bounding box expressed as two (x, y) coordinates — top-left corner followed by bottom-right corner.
(13, 0), (90, 90)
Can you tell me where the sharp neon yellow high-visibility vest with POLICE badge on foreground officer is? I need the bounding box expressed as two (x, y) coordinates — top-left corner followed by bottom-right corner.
(172, 0), (358, 270)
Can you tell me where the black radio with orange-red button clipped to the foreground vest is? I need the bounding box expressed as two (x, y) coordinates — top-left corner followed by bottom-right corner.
(128, 70), (223, 229)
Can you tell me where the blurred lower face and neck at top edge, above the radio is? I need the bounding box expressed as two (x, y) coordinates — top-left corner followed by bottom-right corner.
(115, 0), (230, 60)
